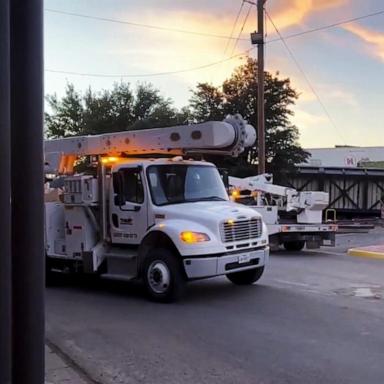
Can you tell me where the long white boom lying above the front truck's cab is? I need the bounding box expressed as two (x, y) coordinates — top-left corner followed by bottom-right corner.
(44, 115), (256, 174)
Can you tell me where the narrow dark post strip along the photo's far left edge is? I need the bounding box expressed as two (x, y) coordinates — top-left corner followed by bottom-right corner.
(0, 0), (11, 384)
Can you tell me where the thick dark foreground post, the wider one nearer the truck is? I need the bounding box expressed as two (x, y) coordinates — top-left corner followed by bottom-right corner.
(11, 0), (45, 384)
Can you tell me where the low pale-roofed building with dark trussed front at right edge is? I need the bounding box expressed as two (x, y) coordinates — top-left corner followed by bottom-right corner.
(288, 147), (384, 218)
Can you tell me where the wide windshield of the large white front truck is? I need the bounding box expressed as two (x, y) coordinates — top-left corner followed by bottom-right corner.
(147, 164), (228, 205)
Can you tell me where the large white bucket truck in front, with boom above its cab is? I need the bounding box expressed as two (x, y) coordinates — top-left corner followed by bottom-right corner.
(44, 115), (269, 301)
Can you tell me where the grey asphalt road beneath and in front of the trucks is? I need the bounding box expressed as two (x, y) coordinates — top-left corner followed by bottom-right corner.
(47, 229), (384, 384)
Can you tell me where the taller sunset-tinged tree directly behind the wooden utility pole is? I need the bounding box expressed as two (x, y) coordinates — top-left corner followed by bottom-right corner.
(190, 58), (309, 178)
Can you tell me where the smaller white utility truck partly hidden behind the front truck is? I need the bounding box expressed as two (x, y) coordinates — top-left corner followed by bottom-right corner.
(228, 174), (337, 251)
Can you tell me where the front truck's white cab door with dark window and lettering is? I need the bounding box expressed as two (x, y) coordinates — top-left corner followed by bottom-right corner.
(110, 165), (148, 244)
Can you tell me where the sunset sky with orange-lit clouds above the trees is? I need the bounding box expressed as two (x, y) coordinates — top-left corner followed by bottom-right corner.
(44, 0), (384, 148)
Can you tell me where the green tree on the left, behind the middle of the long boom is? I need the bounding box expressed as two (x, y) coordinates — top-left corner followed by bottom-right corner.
(45, 82), (182, 138)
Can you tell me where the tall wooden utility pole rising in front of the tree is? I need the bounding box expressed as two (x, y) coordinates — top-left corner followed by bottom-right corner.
(251, 0), (266, 174)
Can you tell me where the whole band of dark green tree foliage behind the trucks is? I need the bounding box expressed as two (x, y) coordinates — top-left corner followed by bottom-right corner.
(45, 58), (309, 176)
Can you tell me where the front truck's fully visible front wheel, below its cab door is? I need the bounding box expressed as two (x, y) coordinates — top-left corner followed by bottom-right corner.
(143, 248), (186, 303)
